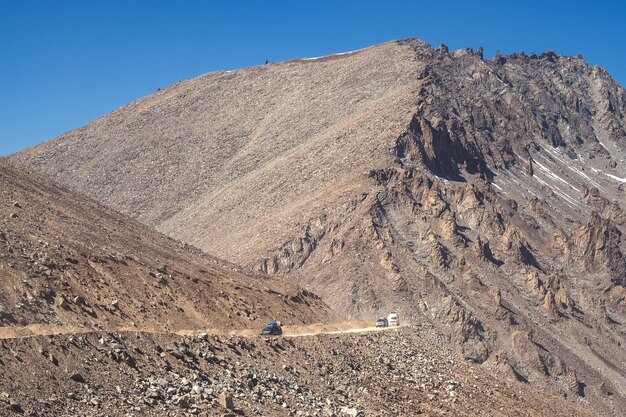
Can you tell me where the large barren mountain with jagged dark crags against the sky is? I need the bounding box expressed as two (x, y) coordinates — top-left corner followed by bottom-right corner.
(8, 40), (626, 415)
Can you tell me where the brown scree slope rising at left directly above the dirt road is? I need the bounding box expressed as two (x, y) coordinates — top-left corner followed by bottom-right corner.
(0, 160), (333, 337)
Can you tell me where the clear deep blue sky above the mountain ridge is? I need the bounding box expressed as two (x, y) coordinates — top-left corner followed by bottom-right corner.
(0, 0), (626, 155)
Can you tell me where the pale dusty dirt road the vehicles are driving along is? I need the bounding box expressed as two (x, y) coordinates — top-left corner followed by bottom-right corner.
(0, 321), (407, 339)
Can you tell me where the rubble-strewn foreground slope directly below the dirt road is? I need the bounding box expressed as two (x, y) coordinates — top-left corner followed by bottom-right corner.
(0, 327), (595, 417)
